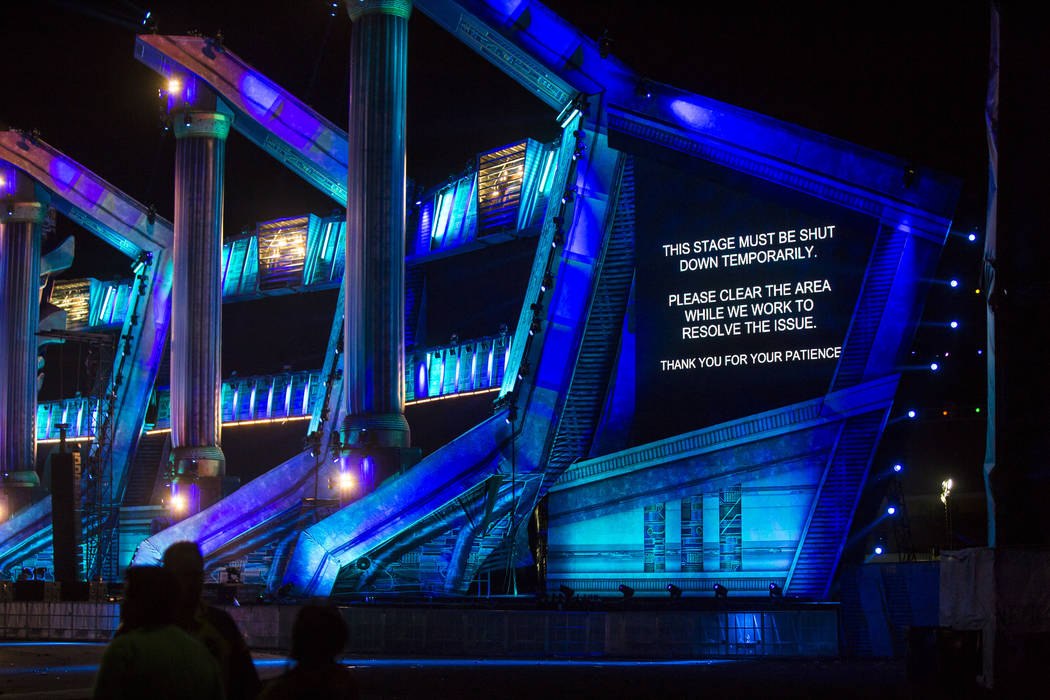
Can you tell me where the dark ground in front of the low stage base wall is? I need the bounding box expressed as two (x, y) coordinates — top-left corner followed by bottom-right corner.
(0, 642), (986, 700)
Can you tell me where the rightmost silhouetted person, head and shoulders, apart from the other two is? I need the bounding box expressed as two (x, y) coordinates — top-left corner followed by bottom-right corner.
(259, 602), (358, 700)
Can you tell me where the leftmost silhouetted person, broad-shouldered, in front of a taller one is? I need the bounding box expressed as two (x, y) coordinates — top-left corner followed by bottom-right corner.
(95, 567), (226, 700)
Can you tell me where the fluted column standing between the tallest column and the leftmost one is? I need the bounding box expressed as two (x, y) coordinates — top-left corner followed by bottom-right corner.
(171, 106), (230, 512)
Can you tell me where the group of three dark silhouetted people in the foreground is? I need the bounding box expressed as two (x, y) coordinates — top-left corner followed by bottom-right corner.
(95, 542), (358, 700)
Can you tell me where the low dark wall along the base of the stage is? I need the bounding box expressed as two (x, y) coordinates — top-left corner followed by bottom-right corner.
(0, 602), (838, 659)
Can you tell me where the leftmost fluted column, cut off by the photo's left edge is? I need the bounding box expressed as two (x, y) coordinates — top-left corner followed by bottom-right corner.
(0, 168), (48, 505)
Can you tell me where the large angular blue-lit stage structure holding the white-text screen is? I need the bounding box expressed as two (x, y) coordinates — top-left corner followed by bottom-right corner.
(0, 0), (958, 599)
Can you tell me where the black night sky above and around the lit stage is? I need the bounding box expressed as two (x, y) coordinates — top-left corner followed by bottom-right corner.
(0, 0), (988, 544)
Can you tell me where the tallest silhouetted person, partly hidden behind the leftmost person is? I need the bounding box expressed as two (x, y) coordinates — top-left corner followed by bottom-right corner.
(164, 542), (261, 700)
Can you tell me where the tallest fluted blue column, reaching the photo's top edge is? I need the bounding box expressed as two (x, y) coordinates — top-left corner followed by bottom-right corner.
(343, 0), (412, 449)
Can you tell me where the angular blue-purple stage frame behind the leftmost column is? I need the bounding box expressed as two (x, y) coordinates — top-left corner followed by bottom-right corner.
(0, 130), (172, 578)
